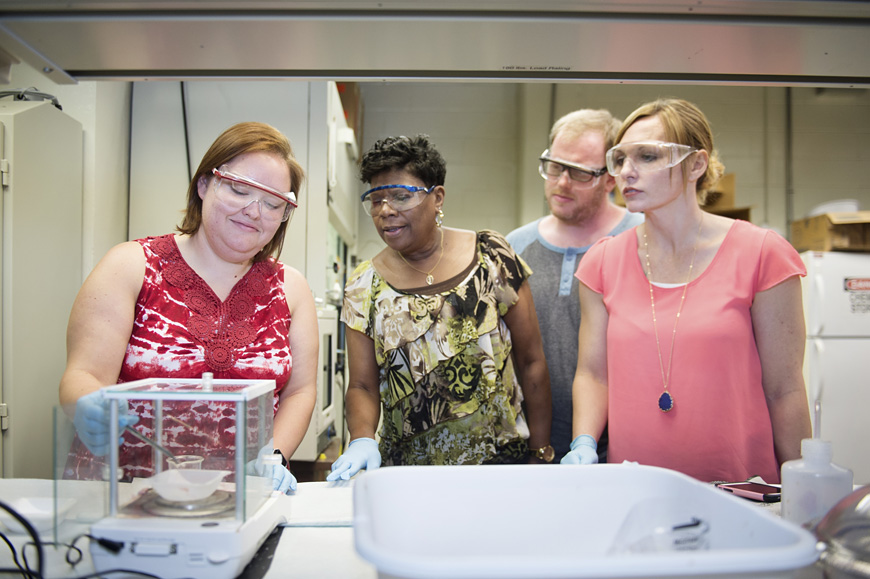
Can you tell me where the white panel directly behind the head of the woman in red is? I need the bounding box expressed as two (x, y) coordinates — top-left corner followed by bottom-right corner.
(129, 80), (318, 286)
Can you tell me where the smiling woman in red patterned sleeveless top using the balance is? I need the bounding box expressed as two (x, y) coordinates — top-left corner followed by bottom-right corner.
(60, 123), (318, 491)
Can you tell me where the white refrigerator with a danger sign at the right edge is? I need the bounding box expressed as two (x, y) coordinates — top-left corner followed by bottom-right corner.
(801, 251), (870, 484)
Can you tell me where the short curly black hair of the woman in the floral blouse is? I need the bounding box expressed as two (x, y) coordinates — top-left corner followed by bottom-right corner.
(359, 134), (447, 187)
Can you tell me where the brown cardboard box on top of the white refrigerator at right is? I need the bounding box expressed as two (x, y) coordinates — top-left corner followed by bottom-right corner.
(791, 211), (870, 251)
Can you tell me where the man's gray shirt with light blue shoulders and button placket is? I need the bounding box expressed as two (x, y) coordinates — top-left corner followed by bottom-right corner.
(507, 213), (643, 462)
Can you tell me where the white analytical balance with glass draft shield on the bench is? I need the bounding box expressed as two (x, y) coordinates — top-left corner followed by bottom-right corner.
(83, 378), (286, 579)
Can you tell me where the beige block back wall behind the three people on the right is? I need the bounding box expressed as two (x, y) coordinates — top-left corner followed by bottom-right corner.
(357, 82), (870, 259)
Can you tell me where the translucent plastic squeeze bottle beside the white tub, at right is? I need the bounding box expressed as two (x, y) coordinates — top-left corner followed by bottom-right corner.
(781, 438), (852, 527)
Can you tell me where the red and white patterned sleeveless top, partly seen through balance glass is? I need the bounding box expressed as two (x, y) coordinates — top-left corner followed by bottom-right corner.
(64, 235), (292, 479)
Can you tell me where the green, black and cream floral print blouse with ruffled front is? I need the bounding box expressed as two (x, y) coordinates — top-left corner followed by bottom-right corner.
(341, 230), (531, 465)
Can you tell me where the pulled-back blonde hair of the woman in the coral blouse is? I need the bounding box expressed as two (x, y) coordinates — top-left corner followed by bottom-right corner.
(616, 98), (725, 205)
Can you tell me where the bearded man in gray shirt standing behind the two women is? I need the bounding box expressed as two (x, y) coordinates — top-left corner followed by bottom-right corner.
(507, 109), (643, 462)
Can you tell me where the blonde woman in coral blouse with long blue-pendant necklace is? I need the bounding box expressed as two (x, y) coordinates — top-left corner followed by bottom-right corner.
(562, 99), (810, 482)
